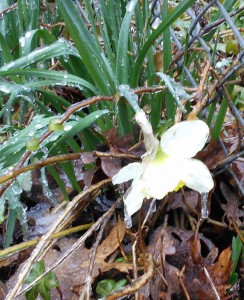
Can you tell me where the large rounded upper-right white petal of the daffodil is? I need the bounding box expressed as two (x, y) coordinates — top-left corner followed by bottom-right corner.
(160, 120), (209, 158)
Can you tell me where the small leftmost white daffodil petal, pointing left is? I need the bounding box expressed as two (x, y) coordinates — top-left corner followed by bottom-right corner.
(112, 162), (143, 184)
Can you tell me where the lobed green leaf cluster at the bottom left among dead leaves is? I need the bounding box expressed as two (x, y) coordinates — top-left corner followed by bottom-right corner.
(25, 261), (59, 300)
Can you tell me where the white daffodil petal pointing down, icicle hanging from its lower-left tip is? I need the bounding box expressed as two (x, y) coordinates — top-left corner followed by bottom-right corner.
(124, 178), (145, 216)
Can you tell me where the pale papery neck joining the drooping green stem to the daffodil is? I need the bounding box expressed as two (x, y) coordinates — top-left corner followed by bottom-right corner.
(135, 109), (159, 156)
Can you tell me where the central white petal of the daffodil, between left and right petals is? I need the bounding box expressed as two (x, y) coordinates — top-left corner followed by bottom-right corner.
(143, 158), (181, 199)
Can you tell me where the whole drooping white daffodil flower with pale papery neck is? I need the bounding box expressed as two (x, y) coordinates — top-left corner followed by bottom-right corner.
(112, 112), (214, 216)
